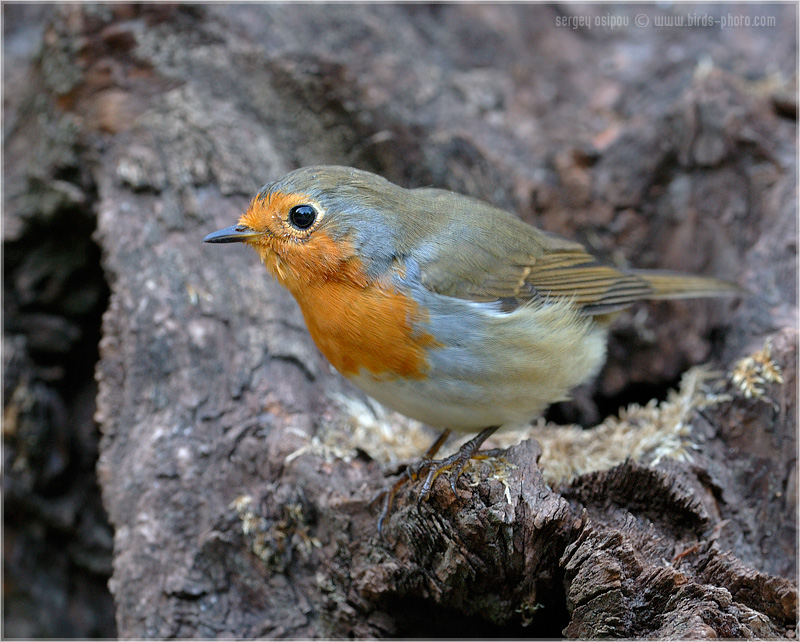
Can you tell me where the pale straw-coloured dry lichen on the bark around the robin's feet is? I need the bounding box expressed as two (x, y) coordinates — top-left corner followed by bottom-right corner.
(287, 364), (732, 484)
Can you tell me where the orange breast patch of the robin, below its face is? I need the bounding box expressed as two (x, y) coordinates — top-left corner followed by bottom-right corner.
(295, 280), (437, 379)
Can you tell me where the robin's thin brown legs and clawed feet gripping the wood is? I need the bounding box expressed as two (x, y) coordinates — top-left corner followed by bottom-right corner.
(376, 426), (499, 539)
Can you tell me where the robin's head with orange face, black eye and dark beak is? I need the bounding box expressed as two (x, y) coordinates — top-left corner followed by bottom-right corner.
(204, 166), (408, 292)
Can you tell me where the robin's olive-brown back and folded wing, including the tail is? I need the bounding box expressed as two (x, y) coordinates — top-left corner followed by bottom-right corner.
(406, 190), (741, 315)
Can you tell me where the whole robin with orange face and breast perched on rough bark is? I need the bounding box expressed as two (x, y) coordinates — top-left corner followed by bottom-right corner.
(204, 166), (742, 532)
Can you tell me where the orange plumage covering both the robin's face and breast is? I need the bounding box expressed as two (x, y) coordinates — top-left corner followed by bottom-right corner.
(234, 192), (436, 378)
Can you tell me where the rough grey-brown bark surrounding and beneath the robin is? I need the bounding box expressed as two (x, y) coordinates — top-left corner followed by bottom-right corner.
(3, 4), (797, 638)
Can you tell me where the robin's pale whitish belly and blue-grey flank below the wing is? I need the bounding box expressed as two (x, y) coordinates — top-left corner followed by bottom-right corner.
(350, 294), (606, 431)
